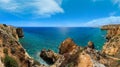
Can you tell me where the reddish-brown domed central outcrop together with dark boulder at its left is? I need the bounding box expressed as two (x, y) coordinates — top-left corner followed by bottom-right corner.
(40, 38), (80, 67)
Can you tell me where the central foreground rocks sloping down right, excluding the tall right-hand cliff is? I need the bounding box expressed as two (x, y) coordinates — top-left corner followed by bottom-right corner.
(40, 38), (117, 67)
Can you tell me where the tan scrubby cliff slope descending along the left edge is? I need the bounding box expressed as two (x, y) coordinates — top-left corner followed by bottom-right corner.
(0, 24), (42, 67)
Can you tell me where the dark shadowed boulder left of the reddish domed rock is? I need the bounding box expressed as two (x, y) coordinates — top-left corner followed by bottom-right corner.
(40, 49), (65, 67)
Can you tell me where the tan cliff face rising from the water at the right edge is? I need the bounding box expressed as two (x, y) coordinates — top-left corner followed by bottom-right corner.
(102, 25), (120, 58)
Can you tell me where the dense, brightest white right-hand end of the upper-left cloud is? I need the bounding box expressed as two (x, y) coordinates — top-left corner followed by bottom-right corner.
(31, 0), (64, 16)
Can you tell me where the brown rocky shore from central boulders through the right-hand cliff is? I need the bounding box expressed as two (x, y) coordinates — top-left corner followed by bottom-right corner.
(40, 25), (120, 67)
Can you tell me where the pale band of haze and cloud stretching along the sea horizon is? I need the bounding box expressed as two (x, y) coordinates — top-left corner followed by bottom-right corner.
(1, 16), (120, 27)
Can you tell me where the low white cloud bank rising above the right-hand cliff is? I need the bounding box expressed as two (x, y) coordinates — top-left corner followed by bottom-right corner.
(81, 16), (120, 27)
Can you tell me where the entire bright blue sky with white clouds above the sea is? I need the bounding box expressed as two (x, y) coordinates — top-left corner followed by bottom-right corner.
(0, 0), (120, 27)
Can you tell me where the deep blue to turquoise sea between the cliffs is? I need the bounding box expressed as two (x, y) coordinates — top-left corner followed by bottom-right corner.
(20, 27), (106, 63)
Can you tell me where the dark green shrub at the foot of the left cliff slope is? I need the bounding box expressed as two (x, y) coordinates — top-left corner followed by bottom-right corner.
(4, 55), (18, 67)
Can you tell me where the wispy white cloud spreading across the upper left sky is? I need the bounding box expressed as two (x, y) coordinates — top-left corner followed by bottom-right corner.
(0, 0), (64, 16)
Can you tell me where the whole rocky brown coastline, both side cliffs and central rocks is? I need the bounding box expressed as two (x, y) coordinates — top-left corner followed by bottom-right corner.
(0, 24), (120, 67)
